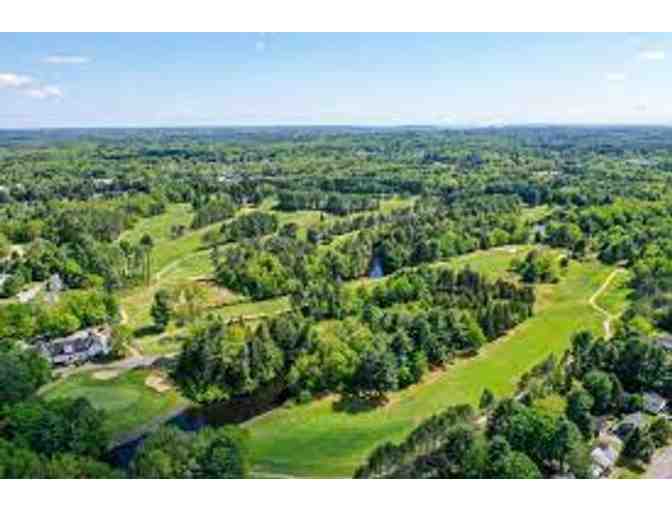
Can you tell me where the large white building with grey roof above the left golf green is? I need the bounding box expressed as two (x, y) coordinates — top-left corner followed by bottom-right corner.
(39, 327), (110, 366)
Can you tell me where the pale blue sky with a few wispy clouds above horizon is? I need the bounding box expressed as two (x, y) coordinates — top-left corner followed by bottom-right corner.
(0, 33), (672, 129)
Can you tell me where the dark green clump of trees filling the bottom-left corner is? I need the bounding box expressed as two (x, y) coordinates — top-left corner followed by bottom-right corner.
(0, 350), (121, 478)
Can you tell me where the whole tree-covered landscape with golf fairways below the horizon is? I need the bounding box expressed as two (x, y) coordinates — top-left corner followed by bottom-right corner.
(0, 126), (672, 478)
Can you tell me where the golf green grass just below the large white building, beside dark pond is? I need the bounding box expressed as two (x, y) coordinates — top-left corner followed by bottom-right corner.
(43, 369), (188, 439)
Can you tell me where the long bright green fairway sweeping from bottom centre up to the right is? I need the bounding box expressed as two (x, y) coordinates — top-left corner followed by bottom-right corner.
(248, 250), (612, 477)
